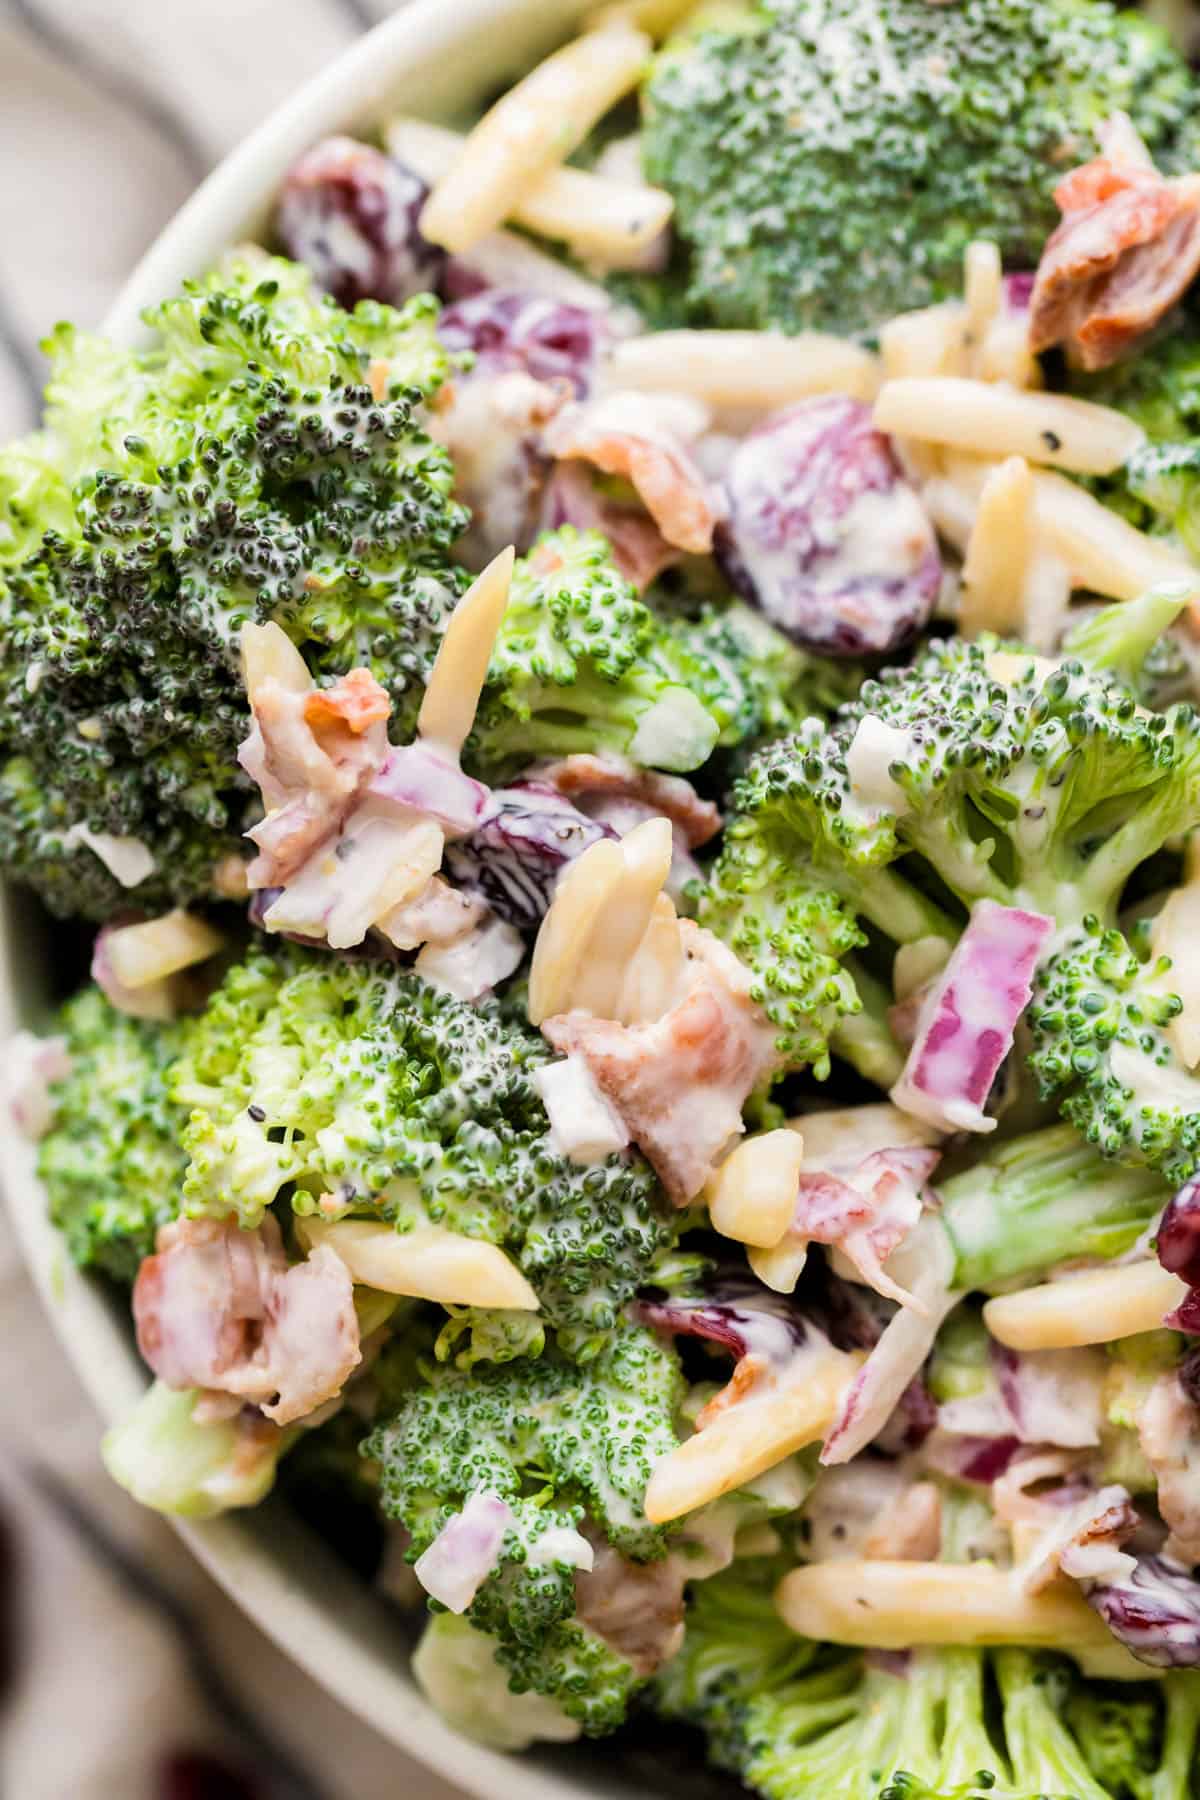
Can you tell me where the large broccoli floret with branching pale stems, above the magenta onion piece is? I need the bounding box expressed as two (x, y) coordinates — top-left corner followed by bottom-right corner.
(700, 641), (1200, 1073)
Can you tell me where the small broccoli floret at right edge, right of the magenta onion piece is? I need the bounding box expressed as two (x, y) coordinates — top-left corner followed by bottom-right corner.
(1029, 918), (1200, 1186)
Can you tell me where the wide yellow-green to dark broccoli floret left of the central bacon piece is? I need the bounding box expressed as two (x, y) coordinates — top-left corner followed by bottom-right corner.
(169, 950), (676, 1355)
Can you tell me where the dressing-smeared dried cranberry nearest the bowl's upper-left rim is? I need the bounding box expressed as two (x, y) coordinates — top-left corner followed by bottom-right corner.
(275, 137), (446, 308)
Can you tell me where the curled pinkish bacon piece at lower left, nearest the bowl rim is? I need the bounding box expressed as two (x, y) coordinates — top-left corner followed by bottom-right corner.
(133, 1213), (360, 1426)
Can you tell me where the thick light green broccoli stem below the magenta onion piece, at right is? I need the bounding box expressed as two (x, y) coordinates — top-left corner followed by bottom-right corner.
(941, 1125), (1168, 1289)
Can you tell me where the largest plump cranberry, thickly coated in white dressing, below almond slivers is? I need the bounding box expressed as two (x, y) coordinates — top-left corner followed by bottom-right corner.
(716, 396), (941, 655)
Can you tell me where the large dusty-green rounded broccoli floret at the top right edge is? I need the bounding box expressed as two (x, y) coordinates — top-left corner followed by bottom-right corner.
(642, 0), (1196, 331)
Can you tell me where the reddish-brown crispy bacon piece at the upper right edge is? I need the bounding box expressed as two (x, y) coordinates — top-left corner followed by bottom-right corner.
(1029, 157), (1200, 369)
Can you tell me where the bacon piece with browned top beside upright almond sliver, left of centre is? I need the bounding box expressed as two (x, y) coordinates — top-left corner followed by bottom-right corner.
(237, 670), (392, 887)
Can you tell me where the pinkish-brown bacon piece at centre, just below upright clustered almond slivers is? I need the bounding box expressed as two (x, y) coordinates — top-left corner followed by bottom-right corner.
(542, 920), (775, 1206)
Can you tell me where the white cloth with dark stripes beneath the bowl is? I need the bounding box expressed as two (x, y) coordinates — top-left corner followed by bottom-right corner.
(0, 0), (467, 1800)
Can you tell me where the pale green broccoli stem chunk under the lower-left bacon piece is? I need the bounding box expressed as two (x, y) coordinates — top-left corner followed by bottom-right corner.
(101, 1381), (288, 1519)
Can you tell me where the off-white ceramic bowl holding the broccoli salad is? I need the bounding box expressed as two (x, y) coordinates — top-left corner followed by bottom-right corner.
(0, 0), (703, 1800)
